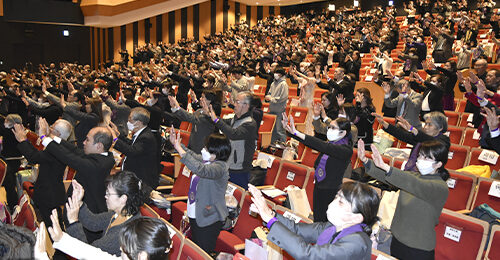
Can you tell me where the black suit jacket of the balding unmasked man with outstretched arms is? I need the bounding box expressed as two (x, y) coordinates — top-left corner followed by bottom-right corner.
(45, 141), (115, 213)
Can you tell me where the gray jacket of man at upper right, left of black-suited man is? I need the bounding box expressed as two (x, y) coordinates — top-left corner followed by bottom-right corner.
(384, 91), (423, 129)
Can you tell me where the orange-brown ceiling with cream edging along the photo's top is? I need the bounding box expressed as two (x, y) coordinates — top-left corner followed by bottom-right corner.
(80, 0), (317, 27)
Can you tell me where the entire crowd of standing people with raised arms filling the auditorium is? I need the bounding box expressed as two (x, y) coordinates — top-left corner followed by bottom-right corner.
(0, 0), (500, 259)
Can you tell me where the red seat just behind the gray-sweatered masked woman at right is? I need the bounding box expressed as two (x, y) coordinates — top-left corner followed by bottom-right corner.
(444, 170), (477, 211)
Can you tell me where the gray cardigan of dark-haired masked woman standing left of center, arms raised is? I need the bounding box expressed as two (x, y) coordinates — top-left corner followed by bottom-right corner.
(181, 149), (229, 227)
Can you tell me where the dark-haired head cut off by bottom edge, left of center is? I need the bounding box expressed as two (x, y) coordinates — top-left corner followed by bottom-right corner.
(120, 217), (172, 260)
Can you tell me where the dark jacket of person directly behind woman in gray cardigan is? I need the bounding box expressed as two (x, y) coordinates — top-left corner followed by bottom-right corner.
(174, 108), (215, 154)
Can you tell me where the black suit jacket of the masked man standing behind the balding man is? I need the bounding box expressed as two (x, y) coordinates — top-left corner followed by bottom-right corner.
(114, 127), (160, 189)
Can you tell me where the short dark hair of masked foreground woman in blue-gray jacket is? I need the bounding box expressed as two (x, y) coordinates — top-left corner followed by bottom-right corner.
(340, 181), (380, 235)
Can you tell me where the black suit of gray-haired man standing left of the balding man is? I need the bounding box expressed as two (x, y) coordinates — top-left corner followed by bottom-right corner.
(17, 140), (66, 226)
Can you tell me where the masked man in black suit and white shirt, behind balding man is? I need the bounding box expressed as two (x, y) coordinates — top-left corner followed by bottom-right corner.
(112, 107), (160, 189)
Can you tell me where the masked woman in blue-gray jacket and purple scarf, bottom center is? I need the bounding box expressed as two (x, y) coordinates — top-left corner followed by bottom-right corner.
(248, 182), (380, 260)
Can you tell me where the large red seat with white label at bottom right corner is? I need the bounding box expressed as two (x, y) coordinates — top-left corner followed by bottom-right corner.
(435, 209), (488, 260)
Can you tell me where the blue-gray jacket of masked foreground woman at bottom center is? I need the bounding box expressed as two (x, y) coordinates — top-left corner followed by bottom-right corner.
(267, 214), (372, 260)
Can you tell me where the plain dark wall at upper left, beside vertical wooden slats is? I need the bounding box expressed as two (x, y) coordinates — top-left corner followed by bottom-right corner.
(0, 17), (90, 70)
